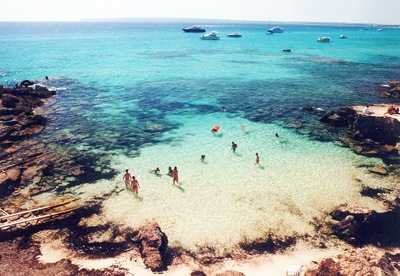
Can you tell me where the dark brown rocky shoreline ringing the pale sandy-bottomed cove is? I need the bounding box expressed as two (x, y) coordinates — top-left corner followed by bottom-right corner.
(0, 81), (400, 276)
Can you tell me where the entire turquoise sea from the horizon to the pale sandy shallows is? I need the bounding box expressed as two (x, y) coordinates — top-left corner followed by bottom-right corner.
(0, 22), (400, 252)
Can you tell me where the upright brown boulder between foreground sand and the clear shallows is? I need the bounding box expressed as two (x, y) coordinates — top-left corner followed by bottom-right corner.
(137, 222), (168, 271)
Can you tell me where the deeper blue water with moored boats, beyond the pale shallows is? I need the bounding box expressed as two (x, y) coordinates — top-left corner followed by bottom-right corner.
(0, 22), (400, 154)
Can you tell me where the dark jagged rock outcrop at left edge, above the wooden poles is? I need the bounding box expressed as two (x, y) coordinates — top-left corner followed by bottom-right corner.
(0, 86), (55, 196)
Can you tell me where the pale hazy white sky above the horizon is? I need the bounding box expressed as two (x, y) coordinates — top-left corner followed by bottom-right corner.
(0, 0), (400, 25)
